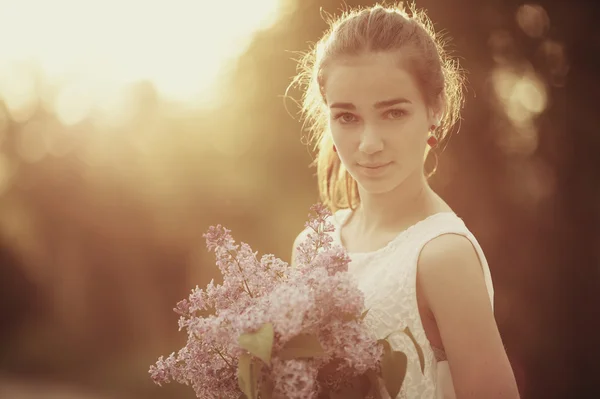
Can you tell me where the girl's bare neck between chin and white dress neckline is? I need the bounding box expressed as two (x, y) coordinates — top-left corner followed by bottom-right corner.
(355, 173), (443, 234)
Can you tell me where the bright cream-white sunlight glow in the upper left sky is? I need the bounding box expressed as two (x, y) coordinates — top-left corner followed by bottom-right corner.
(0, 0), (289, 125)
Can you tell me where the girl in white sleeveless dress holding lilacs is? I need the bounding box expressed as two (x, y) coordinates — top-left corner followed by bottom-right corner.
(292, 5), (519, 399)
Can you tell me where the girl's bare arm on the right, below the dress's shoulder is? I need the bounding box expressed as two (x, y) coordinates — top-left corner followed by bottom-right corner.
(417, 234), (519, 399)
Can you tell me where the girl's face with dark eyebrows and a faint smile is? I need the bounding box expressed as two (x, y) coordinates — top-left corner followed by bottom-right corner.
(324, 53), (438, 194)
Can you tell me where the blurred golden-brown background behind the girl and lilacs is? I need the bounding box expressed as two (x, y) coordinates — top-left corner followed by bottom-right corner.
(0, 0), (600, 399)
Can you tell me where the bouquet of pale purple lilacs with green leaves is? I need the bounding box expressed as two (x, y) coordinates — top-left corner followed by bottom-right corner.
(149, 204), (423, 399)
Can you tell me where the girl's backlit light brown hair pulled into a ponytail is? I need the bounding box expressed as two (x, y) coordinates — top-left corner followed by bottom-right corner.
(292, 3), (463, 212)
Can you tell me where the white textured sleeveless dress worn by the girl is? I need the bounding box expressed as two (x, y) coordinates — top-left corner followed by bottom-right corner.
(301, 209), (494, 399)
